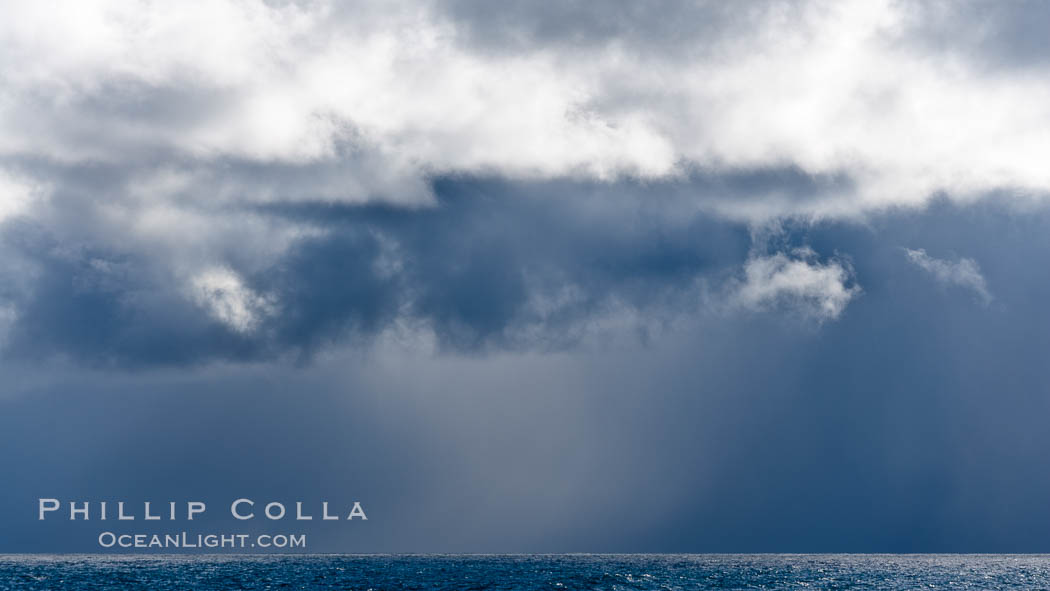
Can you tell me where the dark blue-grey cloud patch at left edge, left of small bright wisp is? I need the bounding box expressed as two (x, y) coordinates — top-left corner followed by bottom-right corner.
(3, 218), (270, 365)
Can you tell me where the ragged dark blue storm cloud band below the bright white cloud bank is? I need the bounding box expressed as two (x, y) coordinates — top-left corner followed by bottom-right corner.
(4, 170), (781, 365)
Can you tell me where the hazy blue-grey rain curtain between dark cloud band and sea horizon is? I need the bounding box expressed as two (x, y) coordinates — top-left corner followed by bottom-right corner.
(6, 202), (1050, 552)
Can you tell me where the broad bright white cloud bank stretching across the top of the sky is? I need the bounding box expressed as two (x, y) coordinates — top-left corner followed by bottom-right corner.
(6, 0), (1050, 218)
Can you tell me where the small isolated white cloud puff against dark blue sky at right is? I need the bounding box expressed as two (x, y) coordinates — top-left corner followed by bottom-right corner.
(731, 249), (861, 321)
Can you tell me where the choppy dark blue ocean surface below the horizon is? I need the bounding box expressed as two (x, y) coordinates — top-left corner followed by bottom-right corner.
(0, 554), (1050, 591)
